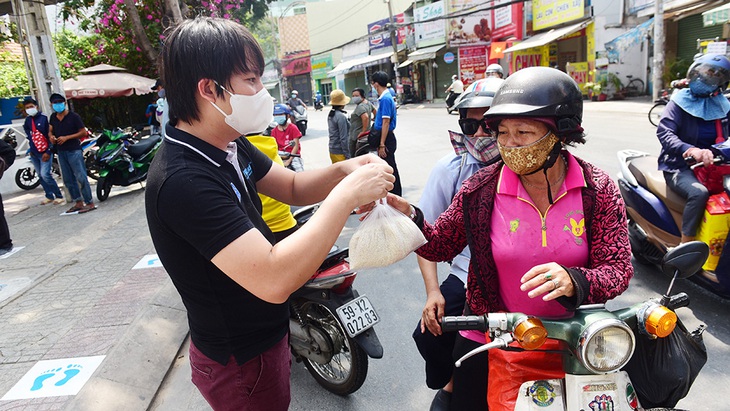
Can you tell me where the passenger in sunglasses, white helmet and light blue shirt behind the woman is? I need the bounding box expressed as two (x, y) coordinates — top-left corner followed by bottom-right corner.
(413, 79), (503, 411)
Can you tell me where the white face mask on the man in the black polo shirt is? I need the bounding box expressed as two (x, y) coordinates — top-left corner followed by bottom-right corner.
(210, 83), (274, 136)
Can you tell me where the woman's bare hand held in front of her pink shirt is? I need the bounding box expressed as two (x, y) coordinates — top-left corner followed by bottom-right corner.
(520, 263), (575, 301)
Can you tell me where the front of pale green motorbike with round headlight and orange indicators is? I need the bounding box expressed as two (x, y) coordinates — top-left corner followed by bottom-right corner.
(442, 241), (708, 411)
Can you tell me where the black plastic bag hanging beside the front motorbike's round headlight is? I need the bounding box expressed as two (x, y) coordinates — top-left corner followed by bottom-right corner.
(624, 319), (707, 408)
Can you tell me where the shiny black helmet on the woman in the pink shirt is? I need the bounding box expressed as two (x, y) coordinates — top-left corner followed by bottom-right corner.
(484, 67), (585, 144)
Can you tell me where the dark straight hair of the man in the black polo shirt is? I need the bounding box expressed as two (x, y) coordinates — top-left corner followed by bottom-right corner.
(160, 17), (264, 122)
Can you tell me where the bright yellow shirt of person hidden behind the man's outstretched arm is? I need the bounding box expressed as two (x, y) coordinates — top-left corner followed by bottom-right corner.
(246, 135), (299, 243)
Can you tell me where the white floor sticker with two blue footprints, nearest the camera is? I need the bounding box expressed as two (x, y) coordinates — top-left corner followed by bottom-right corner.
(2, 355), (106, 400)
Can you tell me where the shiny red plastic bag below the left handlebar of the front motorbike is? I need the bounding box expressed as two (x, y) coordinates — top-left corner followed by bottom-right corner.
(487, 339), (565, 411)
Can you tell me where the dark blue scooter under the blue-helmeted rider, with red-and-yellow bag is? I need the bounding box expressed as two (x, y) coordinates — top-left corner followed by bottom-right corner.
(617, 144), (730, 298)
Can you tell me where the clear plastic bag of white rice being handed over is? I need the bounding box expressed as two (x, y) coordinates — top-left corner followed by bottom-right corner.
(350, 200), (426, 270)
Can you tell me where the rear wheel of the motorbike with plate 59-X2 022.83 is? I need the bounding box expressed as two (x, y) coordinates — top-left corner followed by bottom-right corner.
(302, 303), (368, 395)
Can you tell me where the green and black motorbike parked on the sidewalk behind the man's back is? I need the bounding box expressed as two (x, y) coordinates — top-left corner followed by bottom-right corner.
(95, 129), (162, 201)
